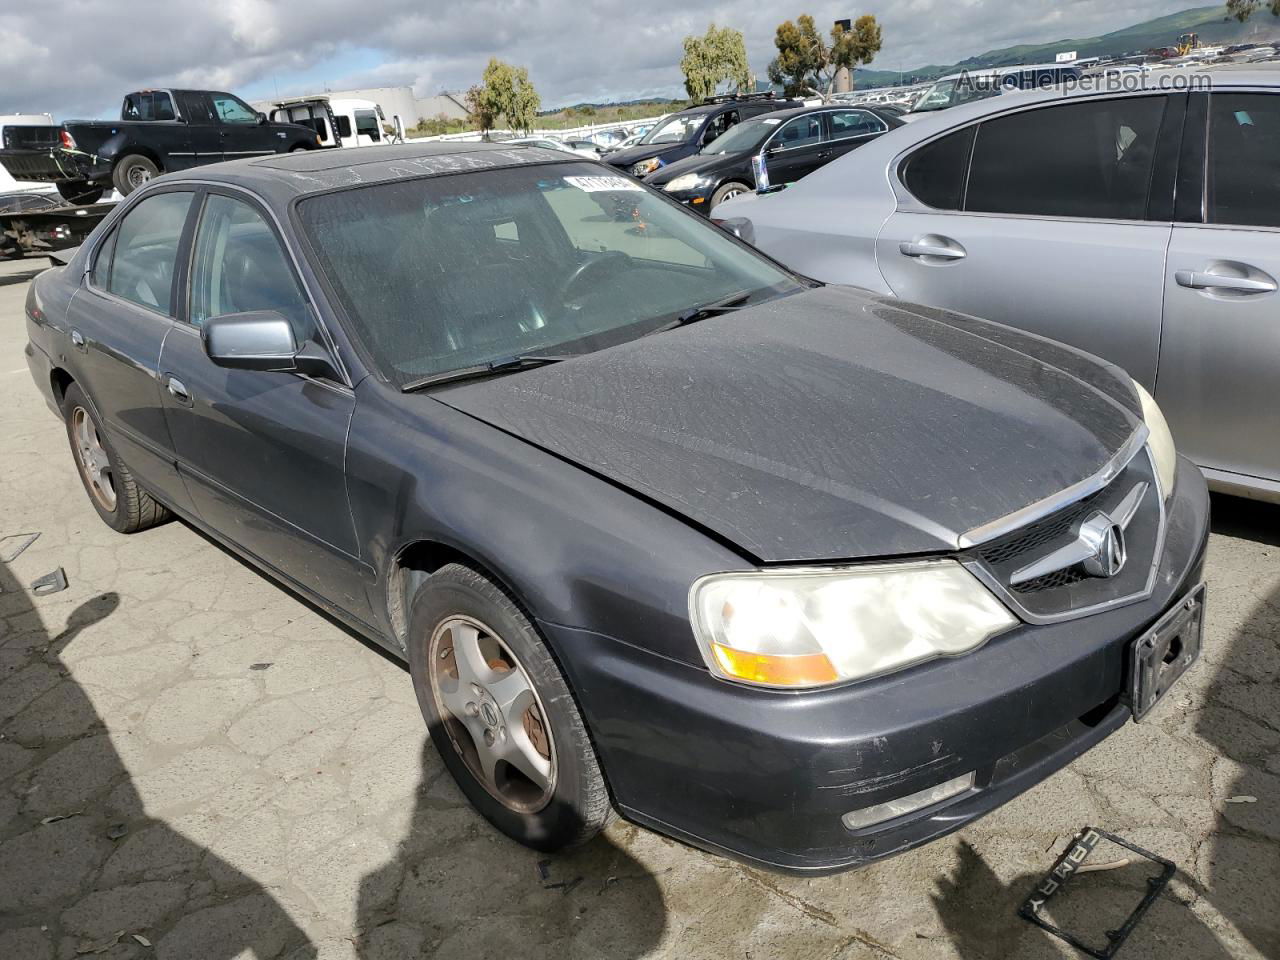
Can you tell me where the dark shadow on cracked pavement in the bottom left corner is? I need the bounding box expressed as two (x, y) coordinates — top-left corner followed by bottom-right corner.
(0, 563), (315, 960)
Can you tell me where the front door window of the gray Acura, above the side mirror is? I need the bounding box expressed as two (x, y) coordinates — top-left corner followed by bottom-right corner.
(191, 193), (314, 343)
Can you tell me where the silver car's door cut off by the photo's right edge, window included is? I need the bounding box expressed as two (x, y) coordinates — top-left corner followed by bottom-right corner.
(1156, 91), (1280, 485)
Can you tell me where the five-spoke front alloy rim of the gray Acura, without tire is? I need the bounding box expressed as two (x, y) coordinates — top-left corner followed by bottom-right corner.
(428, 616), (556, 814)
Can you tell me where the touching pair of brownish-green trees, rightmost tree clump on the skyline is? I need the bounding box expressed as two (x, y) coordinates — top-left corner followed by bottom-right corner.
(769, 12), (880, 97)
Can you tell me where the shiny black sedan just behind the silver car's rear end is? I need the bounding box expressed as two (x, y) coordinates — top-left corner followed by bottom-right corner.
(644, 106), (902, 214)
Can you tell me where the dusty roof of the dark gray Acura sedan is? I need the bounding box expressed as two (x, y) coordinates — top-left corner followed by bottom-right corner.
(154, 141), (586, 205)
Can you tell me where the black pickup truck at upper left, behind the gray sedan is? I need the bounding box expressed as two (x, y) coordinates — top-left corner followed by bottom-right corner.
(0, 90), (319, 204)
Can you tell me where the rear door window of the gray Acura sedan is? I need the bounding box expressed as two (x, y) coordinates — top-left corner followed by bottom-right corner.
(93, 191), (192, 315)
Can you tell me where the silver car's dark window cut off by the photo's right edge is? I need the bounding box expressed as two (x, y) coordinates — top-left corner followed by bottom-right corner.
(1206, 93), (1280, 227)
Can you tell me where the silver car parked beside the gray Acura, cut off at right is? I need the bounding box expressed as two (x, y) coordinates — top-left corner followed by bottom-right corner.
(717, 70), (1280, 499)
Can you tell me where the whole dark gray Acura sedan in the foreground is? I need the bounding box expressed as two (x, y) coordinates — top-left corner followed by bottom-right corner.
(27, 143), (1208, 872)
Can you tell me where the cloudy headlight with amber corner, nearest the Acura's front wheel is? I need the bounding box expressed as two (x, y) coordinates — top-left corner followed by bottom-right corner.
(689, 561), (1018, 687)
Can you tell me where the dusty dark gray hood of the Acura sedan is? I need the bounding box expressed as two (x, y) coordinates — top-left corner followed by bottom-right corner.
(434, 287), (1139, 562)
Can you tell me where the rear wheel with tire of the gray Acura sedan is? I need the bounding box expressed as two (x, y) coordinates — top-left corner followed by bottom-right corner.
(63, 384), (172, 534)
